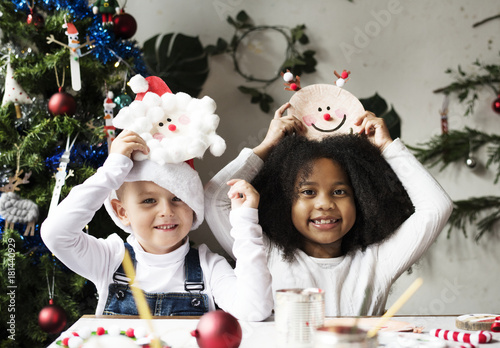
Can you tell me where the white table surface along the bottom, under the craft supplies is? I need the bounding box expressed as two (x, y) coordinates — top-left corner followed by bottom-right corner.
(49, 315), (500, 348)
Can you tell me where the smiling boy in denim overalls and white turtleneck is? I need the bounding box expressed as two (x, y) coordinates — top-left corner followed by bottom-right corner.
(41, 130), (273, 321)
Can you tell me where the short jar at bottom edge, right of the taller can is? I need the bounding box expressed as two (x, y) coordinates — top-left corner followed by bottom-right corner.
(313, 325), (378, 348)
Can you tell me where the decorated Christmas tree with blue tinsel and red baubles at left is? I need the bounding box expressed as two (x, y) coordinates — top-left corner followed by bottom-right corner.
(0, 0), (149, 347)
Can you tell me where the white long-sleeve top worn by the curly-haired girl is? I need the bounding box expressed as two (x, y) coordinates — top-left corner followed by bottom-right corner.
(205, 139), (452, 316)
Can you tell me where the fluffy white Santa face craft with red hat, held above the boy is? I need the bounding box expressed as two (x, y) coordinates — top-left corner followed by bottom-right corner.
(113, 75), (226, 165)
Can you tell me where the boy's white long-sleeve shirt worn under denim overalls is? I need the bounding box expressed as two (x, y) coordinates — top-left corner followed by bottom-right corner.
(40, 154), (273, 321)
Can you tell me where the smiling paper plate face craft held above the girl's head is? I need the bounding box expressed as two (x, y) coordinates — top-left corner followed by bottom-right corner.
(282, 70), (365, 139)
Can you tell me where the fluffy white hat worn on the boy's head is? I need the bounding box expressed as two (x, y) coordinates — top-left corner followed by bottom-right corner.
(104, 160), (204, 233)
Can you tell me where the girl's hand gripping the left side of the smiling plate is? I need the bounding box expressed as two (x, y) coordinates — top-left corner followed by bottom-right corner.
(253, 103), (304, 160)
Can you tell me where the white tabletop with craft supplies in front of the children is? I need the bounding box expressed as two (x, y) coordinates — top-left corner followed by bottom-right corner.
(49, 315), (500, 348)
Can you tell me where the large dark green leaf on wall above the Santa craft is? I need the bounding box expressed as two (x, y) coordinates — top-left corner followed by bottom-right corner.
(143, 33), (209, 98)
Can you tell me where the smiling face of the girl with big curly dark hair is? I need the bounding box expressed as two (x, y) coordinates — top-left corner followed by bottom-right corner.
(292, 158), (356, 258)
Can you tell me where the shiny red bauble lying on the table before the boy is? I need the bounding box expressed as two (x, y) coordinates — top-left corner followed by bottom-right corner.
(191, 310), (242, 348)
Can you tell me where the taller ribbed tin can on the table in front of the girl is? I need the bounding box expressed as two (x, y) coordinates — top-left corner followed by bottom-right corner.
(274, 288), (325, 348)
